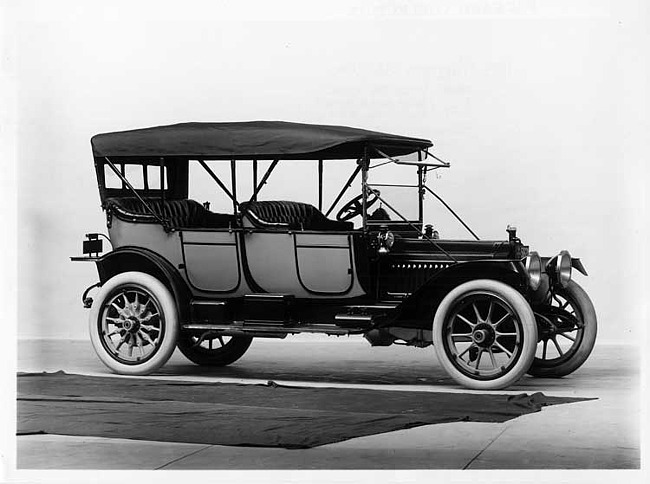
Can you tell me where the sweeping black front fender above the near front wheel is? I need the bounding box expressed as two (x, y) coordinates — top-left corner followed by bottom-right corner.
(386, 260), (528, 329)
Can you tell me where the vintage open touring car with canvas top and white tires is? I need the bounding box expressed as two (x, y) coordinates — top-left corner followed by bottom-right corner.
(72, 121), (596, 389)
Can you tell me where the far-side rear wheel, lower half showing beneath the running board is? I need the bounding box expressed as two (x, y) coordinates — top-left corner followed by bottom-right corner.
(178, 332), (253, 366)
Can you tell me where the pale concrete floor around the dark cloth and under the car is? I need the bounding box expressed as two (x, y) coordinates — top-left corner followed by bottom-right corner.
(16, 337), (641, 472)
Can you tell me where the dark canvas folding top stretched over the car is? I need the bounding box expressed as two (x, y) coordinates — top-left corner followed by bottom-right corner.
(91, 121), (432, 159)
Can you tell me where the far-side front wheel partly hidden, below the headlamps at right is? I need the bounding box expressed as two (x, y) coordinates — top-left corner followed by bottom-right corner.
(528, 281), (597, 378)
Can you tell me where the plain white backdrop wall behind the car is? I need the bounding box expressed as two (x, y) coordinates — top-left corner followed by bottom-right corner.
(5, 0), (648, 342)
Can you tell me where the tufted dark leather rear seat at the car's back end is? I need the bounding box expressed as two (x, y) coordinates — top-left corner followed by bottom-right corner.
(106, 197), (235, 228)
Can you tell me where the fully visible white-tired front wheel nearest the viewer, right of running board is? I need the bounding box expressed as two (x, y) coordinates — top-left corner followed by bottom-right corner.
(433, 279), (537, 390)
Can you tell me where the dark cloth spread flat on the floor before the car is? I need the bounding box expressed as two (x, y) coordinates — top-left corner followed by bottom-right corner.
(18, 372), (586, 448)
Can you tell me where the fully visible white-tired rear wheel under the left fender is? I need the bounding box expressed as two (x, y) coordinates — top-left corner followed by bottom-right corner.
(88, 272), (179, 375)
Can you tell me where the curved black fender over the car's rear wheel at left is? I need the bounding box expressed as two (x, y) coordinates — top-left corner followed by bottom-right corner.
(96, 246), (191, 322)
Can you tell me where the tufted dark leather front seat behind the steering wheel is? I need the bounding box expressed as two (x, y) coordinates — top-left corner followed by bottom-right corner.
(239, 200), (354, 230)
